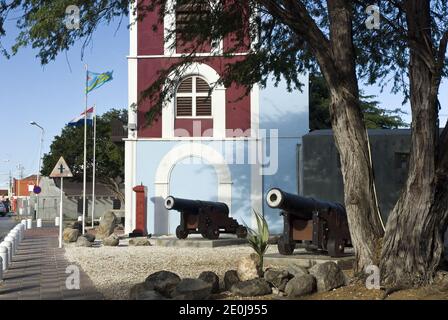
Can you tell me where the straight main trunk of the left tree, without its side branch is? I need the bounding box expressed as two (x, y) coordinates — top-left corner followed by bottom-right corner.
(321, 0), (383, 272)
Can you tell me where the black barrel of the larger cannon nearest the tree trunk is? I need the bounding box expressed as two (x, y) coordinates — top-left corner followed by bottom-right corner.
(266, 188), (346, 220)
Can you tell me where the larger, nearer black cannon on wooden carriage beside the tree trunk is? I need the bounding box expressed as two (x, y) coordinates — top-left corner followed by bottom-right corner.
(266, 188), (351, 257)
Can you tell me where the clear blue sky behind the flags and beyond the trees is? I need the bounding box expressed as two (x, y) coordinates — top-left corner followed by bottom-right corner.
(0, 16), (448, 187)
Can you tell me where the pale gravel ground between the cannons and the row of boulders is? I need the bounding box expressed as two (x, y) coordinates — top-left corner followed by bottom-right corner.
(65, 246), (276, 300)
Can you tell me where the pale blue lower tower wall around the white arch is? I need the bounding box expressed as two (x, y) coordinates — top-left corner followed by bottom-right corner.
(136, 140), (261, 234)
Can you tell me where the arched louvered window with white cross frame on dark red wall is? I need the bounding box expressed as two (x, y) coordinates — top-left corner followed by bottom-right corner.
(176, 76), (212, 118)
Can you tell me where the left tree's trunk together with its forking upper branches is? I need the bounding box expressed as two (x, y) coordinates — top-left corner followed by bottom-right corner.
(259, 0), (383, 272)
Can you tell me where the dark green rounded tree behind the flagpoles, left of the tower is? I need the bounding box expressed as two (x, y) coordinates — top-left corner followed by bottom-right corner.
(42, 109), (127, 201)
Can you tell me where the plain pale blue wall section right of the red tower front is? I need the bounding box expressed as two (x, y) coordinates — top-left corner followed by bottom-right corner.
(260, 75), (309, 233)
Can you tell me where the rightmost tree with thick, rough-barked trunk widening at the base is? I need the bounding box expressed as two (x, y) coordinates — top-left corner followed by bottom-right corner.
(358, 0), (448, 288)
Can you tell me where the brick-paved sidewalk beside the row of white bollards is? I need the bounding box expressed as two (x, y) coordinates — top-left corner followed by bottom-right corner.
(0, 228), (103, 300)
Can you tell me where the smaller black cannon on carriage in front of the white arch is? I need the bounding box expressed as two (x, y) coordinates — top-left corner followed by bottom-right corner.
(165, 197), (247, 240)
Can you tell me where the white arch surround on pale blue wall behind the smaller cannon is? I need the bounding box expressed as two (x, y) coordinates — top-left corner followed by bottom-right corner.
(154, 142), (232, 235)
